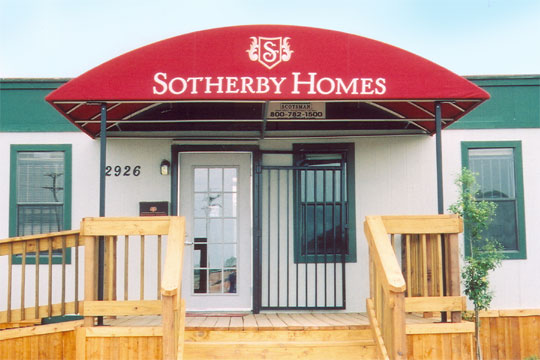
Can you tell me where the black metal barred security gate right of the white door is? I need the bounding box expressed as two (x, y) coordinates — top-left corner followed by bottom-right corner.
(254, 153), (348, 311)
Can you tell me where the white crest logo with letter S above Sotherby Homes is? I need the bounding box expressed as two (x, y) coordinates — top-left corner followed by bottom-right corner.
(246, 36), (294, 69)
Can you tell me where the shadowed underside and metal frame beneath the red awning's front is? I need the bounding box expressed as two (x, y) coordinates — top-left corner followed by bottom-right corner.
(53, 99), (482, 138)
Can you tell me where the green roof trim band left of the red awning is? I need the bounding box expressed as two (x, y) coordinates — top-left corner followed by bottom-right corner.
(0, 79), (80, 132)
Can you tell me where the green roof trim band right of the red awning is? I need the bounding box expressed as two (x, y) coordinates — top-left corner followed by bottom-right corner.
(447, 75), (540, 129)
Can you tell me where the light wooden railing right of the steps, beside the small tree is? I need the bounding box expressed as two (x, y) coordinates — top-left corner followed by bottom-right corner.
(364, 215), (465, 359)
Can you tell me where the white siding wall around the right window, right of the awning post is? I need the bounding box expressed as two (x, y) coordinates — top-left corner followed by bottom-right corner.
(443, 129), (540, 309)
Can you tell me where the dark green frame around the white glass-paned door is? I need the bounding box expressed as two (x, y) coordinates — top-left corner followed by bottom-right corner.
(170, 144), (261, 314)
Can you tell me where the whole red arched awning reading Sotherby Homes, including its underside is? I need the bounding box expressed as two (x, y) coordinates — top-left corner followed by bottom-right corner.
(46, 25), (489, 137)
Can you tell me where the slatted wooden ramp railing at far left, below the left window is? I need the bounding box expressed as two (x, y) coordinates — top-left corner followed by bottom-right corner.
(0, 231), (84, 328)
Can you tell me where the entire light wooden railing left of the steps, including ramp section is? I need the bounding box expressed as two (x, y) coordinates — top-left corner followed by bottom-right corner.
(0, 217), (185, 359)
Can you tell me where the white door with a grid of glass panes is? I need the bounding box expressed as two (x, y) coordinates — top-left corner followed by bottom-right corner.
(178, 153), (252, 311)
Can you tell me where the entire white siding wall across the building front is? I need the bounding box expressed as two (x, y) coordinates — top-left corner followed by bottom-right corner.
(0, 129), (540, 311)
